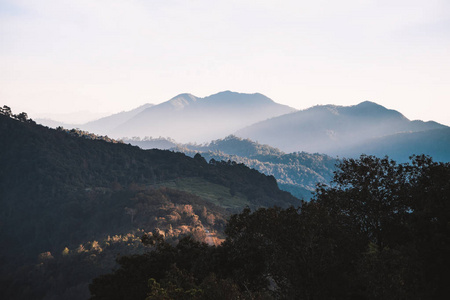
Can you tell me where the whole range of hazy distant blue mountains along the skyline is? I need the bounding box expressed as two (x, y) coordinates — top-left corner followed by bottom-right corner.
(35, 91), (450, 162)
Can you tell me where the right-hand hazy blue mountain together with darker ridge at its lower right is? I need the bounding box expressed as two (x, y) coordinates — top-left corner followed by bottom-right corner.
(236, 101), (450, 160)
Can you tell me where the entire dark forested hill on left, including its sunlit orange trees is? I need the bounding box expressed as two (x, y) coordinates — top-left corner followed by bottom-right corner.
(0, 111), (298, 299)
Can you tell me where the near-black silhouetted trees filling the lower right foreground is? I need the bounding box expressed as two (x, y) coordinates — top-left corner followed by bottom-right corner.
(90, 156), (450, 300)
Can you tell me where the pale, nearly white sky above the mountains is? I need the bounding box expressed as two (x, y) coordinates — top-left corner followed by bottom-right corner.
(0, 0), (450, 125)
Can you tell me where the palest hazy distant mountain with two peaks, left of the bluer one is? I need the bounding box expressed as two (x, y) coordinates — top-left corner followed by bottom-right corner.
(110, 91), (295, 143)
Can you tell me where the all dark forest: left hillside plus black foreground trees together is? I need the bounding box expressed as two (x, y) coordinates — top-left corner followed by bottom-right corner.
(0, 106), (450, 299)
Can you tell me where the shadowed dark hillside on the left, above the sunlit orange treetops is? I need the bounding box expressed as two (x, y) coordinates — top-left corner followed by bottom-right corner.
(0, 110), (299, 300)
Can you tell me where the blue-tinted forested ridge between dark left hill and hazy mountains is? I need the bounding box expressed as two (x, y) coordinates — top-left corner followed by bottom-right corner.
(125, 136), (337, 200)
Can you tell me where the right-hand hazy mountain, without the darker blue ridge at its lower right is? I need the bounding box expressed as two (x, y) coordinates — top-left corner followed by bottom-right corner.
(236, 101), (448, 161)
